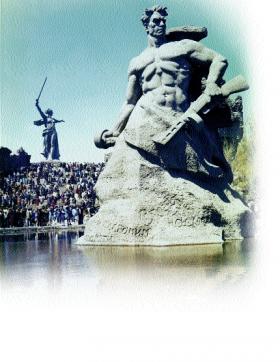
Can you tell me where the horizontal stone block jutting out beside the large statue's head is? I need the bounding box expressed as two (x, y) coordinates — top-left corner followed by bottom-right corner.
(166, 25), (208, 42)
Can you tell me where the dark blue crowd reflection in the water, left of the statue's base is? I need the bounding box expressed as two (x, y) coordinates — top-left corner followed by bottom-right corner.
(0, 231), (87, 287)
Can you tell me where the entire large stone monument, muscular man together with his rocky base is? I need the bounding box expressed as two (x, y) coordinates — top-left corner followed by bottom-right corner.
(79, 6), (250, 246)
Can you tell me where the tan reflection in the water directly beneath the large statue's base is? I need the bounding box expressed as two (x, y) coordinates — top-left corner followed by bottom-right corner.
(79, 240), (253, 289)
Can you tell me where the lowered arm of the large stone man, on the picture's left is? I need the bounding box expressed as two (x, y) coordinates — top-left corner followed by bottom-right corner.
(95, 73), (142, 148)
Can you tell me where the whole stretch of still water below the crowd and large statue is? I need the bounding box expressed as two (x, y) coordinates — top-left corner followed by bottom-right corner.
(0, 231), (252, 288)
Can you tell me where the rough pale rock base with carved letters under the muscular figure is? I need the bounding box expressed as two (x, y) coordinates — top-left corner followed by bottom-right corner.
(78, 139), (253, 246)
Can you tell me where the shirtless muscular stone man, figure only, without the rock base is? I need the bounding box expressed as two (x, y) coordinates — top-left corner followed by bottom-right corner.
(96, 6), (232, 182)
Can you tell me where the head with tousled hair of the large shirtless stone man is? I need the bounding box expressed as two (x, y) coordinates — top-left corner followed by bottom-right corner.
(141, 5), (168, 38)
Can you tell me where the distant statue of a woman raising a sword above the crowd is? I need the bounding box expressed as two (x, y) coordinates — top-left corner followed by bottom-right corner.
(34, 77), (64, 160)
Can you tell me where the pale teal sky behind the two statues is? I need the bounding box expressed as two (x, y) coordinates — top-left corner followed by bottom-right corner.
(0, 0), (251, 162)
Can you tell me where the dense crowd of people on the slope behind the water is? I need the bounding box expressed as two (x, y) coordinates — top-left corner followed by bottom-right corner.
(0, 162), (104, 228)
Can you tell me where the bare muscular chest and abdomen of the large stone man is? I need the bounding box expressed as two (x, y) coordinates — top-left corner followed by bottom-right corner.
(132, 41), (194, 112)
